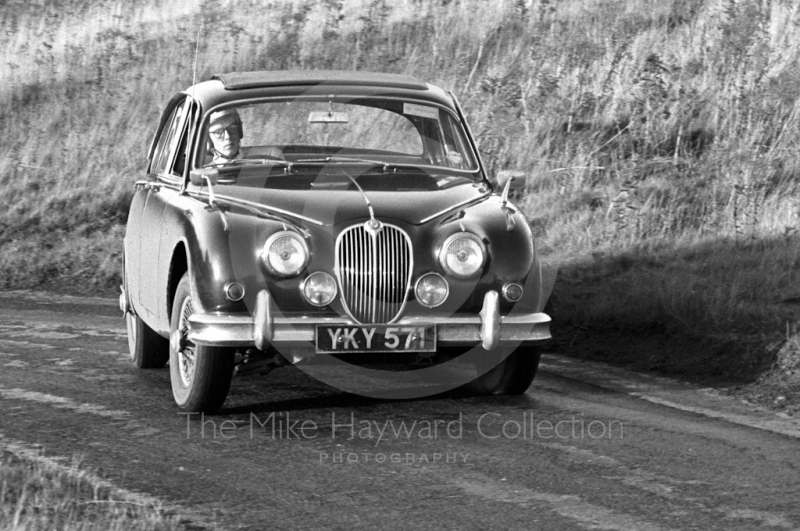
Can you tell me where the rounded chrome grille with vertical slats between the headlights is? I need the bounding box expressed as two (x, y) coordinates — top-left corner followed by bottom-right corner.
(336, 221), (413, 323)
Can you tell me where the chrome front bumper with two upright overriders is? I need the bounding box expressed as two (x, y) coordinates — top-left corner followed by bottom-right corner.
(188, 290), (550, 350)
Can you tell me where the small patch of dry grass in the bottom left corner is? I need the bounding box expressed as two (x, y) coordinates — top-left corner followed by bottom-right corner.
(0, 452), (184, 531)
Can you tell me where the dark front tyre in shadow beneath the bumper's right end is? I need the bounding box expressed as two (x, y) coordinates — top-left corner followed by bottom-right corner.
(475, 346), (542, 395)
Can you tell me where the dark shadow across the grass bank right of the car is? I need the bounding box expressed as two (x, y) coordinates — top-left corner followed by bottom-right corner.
(547, 236), (800, 385)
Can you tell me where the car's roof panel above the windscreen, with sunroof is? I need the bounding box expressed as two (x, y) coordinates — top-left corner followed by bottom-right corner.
(183, 70), (453, 110)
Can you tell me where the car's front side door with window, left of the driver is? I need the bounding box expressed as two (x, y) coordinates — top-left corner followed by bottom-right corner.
(137, 97), (189, 330)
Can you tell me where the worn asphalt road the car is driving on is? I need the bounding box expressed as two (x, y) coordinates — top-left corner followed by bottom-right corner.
(0, 292), (800, 531)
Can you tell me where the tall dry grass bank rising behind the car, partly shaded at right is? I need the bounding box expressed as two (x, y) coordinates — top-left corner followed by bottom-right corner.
(0, 0), (800, 408)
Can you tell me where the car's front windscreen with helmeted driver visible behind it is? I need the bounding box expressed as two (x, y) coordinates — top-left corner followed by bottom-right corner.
(201, 97), (478, 173)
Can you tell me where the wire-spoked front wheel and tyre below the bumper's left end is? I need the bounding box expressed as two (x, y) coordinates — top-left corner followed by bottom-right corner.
(169, 273), (236, 413)
